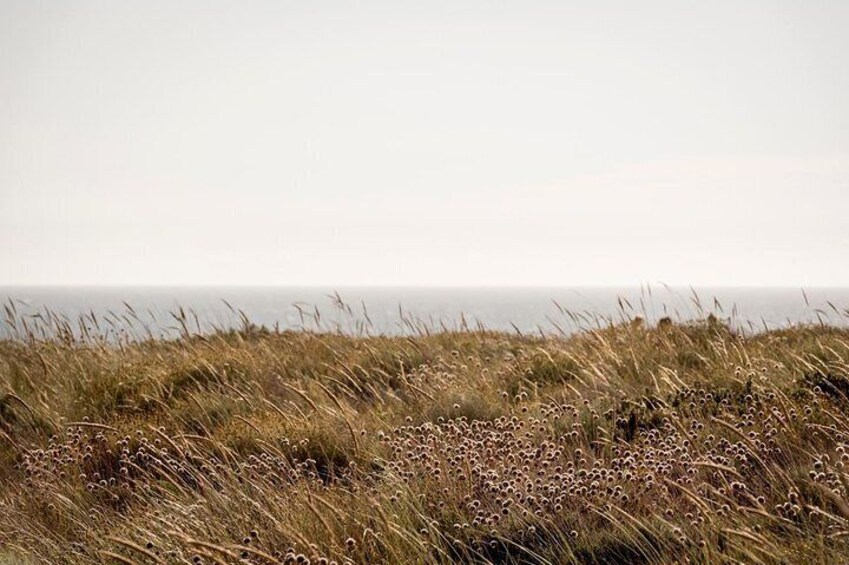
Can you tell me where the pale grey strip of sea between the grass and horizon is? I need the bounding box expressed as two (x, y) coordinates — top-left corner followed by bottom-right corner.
(0, 287), (849, 337)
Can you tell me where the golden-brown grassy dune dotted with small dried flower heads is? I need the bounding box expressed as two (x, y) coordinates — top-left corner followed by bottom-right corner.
(0, 318), (849, 564)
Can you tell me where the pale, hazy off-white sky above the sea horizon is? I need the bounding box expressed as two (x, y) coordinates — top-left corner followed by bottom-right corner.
(0, 0), (849, 286)
